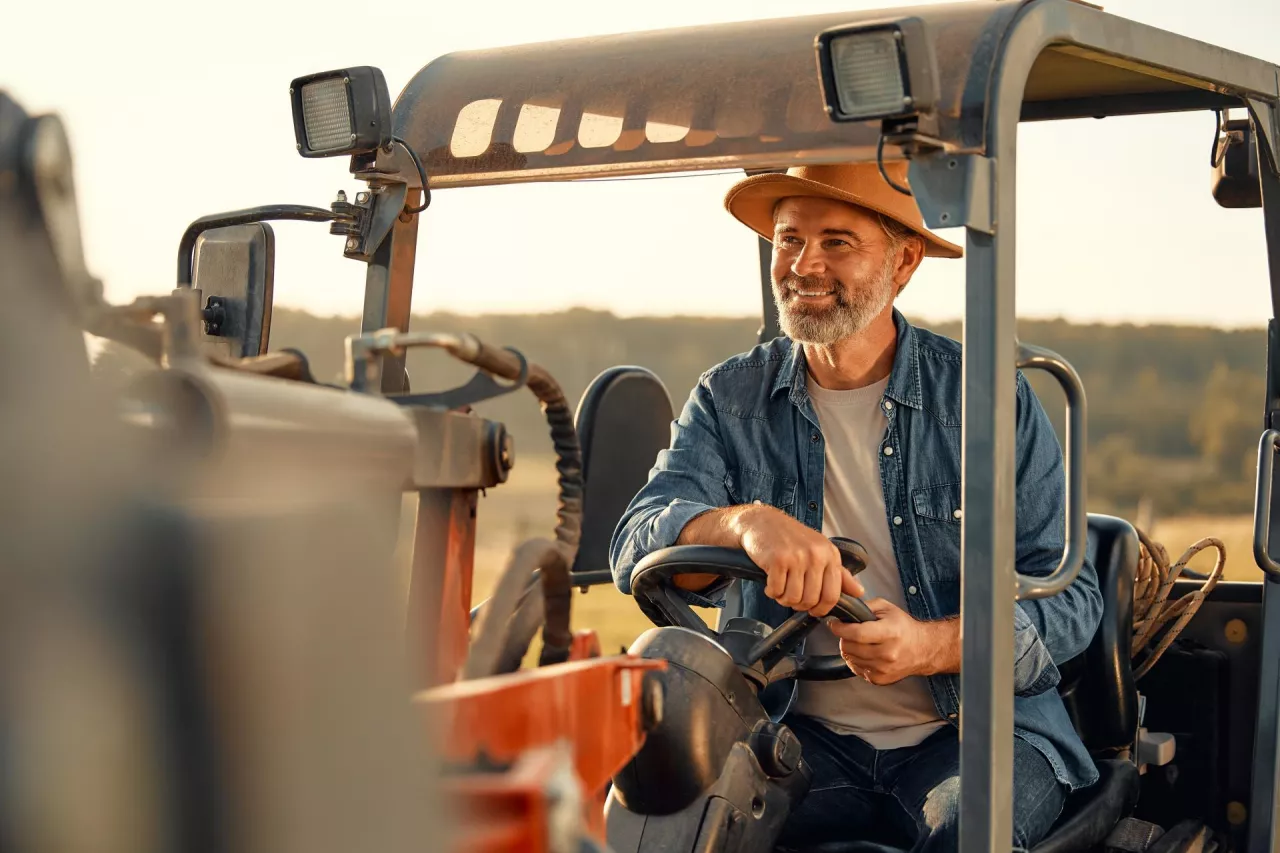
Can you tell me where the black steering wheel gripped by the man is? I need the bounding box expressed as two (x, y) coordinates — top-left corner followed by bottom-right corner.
(631, 537), (876, 686)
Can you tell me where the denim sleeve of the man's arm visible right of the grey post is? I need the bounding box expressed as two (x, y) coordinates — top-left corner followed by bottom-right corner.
(1014, 373), (1102, 695)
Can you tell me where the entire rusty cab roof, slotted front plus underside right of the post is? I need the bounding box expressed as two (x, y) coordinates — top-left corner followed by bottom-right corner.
(391, 0), (1275, 188)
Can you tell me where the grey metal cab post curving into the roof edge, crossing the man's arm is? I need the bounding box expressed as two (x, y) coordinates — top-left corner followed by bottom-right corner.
(957, 1), (1275, 853)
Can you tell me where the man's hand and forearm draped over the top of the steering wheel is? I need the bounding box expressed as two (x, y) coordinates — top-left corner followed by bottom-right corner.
(677, 503), (865, 617)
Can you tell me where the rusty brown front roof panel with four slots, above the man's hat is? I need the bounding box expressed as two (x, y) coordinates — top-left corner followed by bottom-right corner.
(394, 1), (1018, 188)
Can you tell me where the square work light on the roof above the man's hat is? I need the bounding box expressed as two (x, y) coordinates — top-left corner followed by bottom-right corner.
(815, 18), (937, 122)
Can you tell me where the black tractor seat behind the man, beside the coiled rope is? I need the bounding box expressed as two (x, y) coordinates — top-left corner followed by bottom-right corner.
(788, 514), (1139, 853)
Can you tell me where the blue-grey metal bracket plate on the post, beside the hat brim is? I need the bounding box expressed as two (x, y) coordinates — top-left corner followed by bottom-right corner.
(908, 152), (996, 234)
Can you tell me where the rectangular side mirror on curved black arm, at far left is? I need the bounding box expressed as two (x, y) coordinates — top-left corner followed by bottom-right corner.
(191, 223), (275, 359)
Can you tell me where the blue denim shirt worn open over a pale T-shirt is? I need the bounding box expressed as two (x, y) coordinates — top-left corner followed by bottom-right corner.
(609, 310), (1102, 790)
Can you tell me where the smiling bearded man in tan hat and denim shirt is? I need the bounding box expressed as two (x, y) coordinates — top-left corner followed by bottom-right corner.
(611, 164), (1102, 852)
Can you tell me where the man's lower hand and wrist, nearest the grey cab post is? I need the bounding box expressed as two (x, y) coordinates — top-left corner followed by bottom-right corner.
(829, 598), (960, 684)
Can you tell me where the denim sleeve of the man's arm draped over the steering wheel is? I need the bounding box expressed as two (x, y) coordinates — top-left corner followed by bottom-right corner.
(609, 374), (730, 596)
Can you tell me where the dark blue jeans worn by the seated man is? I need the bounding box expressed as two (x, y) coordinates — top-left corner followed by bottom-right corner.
(778, 715), (1066, 853)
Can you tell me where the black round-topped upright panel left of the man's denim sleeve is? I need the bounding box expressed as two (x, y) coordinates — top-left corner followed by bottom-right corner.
(573, 366), (673, 583)
